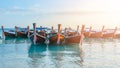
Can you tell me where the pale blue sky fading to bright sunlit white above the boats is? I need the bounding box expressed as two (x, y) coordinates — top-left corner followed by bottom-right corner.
(0, 0), (120, 28)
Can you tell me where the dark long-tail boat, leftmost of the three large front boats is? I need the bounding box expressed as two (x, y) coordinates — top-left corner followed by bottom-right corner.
(30, 23), (47, 44)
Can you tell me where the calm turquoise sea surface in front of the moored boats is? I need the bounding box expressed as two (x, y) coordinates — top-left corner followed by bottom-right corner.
(0, 31), (120, 68)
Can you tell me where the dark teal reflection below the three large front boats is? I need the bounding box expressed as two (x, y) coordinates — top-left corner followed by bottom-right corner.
(28, 44), (83, 68)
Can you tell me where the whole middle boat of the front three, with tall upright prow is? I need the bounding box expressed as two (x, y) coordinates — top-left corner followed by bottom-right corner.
(49, 24), (65, 45)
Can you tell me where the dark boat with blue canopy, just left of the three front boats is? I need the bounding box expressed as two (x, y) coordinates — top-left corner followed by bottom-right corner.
(15, 26), (30, 38)
